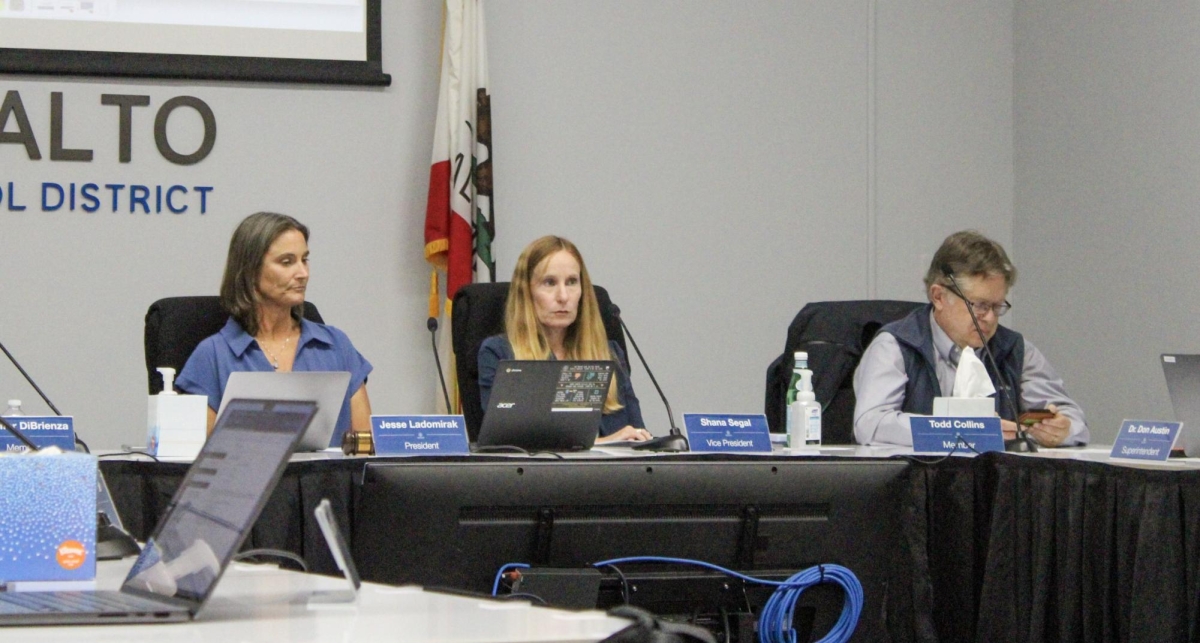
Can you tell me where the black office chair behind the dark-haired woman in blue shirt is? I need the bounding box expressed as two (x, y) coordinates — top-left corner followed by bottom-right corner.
(144, 296), (325, 395)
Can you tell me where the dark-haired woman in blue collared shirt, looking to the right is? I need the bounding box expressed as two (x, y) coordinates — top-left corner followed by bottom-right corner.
(175, 212), (371, 446)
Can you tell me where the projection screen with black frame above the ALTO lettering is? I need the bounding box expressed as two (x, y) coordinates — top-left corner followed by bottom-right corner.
(0, 0), (391, 85)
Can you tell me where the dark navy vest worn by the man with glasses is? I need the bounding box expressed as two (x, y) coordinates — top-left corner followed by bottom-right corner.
(880, 304), (1025, 422)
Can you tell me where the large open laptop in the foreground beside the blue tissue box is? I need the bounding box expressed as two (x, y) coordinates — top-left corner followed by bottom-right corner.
(0, 399), (317, 625)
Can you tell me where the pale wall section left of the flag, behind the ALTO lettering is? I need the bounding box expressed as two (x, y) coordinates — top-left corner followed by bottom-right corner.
(0, 1), (440, 447)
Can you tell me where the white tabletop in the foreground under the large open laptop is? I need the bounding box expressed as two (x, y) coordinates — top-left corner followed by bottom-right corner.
(14, 559), (632, 643)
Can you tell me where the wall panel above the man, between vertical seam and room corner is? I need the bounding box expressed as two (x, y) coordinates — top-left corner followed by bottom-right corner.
(875, 1), (1020, 298)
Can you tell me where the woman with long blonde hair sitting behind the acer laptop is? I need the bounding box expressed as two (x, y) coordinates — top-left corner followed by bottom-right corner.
(479, 236), (650, 444)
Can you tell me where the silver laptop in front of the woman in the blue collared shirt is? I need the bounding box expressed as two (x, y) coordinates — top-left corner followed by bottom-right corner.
(217, 371), (350, 451)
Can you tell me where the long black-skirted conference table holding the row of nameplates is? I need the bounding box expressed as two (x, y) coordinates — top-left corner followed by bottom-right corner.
(101, 446), (1200, 642)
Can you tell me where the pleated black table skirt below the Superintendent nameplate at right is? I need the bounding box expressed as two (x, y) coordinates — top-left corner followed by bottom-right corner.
(906, 455), (1200, 643)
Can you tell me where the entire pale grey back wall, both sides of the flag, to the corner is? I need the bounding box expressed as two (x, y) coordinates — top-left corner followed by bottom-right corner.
(0, 0), (1024, 447)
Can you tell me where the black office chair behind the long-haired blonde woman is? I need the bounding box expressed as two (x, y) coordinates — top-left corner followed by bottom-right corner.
(450, 282), (630, 441)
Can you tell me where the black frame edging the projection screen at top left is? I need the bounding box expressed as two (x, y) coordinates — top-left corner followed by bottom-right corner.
(0, 0), (391, 86)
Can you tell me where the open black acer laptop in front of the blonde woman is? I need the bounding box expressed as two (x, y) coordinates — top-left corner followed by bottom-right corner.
(478, 360), (614, 451)
